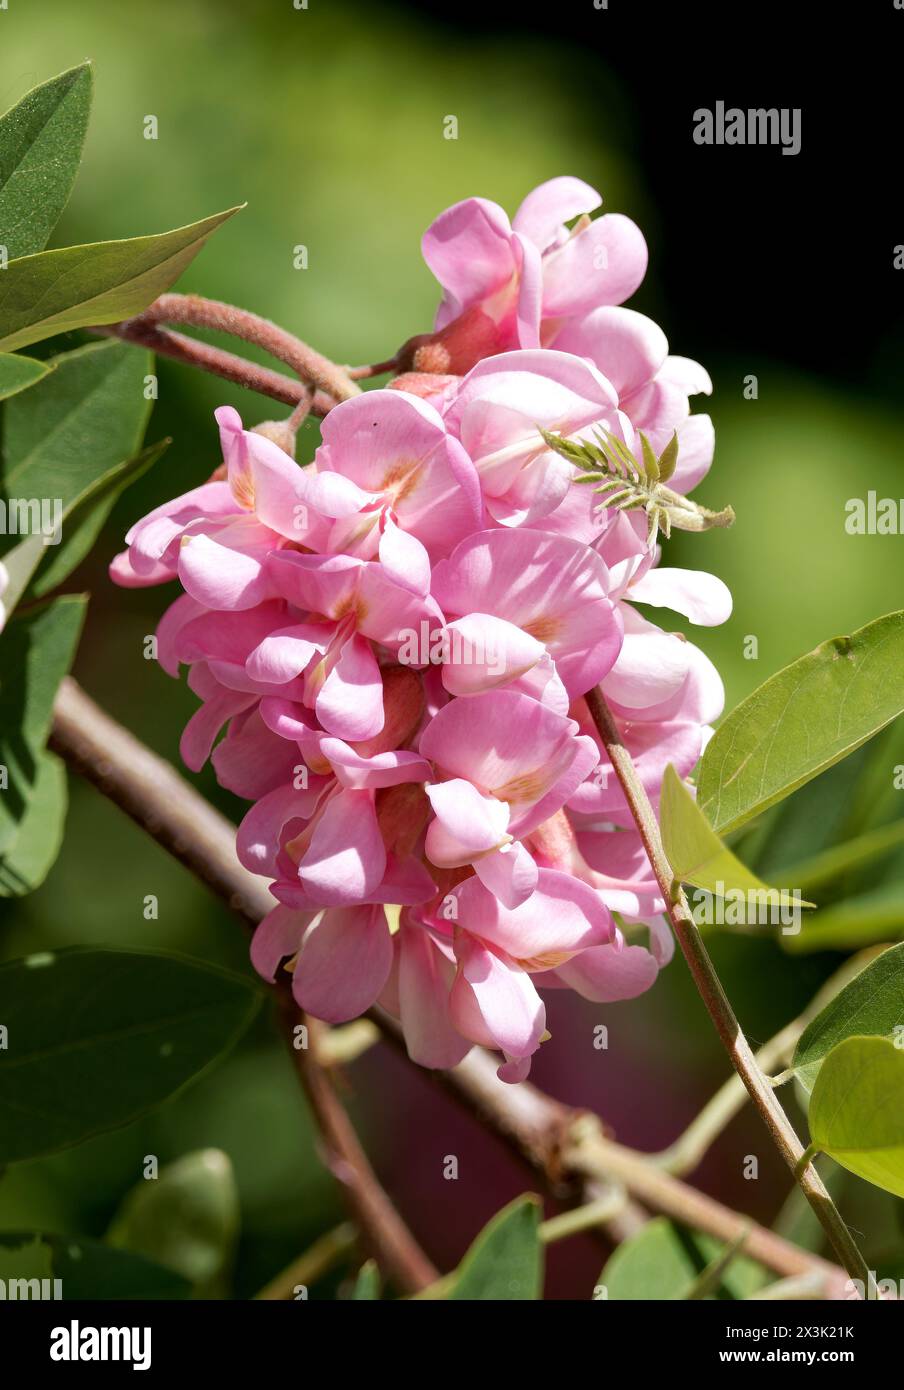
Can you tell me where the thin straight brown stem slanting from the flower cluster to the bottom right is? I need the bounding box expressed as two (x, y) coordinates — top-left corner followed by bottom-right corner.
(586, 688), (873, 1297)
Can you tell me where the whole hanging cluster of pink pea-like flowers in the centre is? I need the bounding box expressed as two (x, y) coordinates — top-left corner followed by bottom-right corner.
(111, 178), (730, 1081)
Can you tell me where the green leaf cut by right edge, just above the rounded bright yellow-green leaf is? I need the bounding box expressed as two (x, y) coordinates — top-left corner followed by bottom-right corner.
(791, 944), (904, 1091)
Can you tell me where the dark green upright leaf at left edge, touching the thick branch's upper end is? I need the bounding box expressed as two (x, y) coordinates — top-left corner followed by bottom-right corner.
(0, 595), (86, 855)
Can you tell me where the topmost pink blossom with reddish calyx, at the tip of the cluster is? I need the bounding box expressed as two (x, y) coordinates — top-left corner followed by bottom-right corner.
(413, 178), (647, 374)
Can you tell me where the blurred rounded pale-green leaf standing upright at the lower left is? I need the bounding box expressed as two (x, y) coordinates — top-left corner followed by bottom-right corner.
(107, 1148), (239, 1298)
